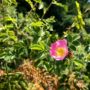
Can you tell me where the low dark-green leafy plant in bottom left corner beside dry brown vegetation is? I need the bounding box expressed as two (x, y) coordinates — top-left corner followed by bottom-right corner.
(0, 73), (28, 90)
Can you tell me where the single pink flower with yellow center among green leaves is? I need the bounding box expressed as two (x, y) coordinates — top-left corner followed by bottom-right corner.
(50, 39), (68, 60)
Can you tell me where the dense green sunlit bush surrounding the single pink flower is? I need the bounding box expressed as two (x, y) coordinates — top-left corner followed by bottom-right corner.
(0, 0), (90, 90)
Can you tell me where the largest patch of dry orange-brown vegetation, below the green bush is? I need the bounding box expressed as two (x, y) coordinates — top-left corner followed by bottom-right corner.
(15, 60), (58, 90)
